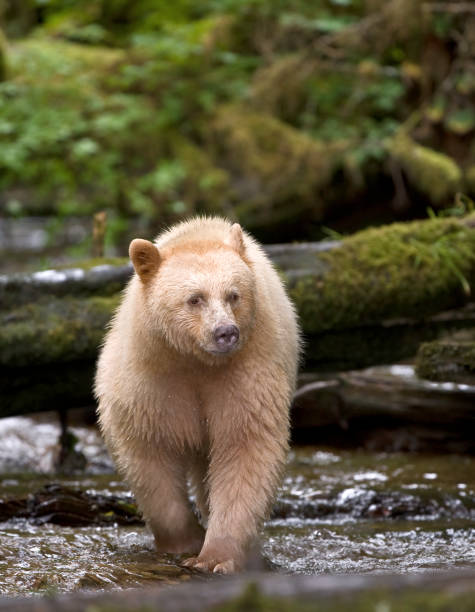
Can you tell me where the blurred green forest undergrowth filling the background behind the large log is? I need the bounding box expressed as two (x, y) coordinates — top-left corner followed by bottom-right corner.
(0, 0), (475, 240)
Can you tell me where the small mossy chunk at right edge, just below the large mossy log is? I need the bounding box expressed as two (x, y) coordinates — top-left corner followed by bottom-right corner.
(416, 341), (475, 384)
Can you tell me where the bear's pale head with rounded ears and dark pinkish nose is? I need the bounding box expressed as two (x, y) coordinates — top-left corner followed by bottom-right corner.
(129, 223), (255, 365)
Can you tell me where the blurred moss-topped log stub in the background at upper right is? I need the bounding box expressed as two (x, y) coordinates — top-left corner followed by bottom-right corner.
(388, 135), (462, 206)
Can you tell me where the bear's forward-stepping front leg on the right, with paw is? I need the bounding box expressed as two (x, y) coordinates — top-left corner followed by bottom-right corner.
(184, 407), (288, 574)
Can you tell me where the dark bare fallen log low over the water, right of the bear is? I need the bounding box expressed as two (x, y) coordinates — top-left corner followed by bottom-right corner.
(292, 365), (475, 454)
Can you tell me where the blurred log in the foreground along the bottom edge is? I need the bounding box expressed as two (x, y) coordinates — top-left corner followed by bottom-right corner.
(0, 571), (475, 612)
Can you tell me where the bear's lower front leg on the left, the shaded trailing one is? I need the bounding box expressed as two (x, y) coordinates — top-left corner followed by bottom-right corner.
(125, 449), (204, 554)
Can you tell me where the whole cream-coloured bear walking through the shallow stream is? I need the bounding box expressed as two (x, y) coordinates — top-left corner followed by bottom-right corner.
(95, 218), (299, 573)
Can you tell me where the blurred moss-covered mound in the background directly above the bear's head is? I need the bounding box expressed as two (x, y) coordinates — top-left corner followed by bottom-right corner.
(208, 106), (335, 227)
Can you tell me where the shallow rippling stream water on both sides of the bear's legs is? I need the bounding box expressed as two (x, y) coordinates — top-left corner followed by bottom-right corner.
(0, 419), (475, 594)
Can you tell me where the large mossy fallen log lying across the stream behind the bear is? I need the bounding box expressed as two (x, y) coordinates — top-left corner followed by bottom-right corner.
(0, 216), (475, 416)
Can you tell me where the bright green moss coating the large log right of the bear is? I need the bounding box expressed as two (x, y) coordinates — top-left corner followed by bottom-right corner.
(289, 213), (475, 333)
